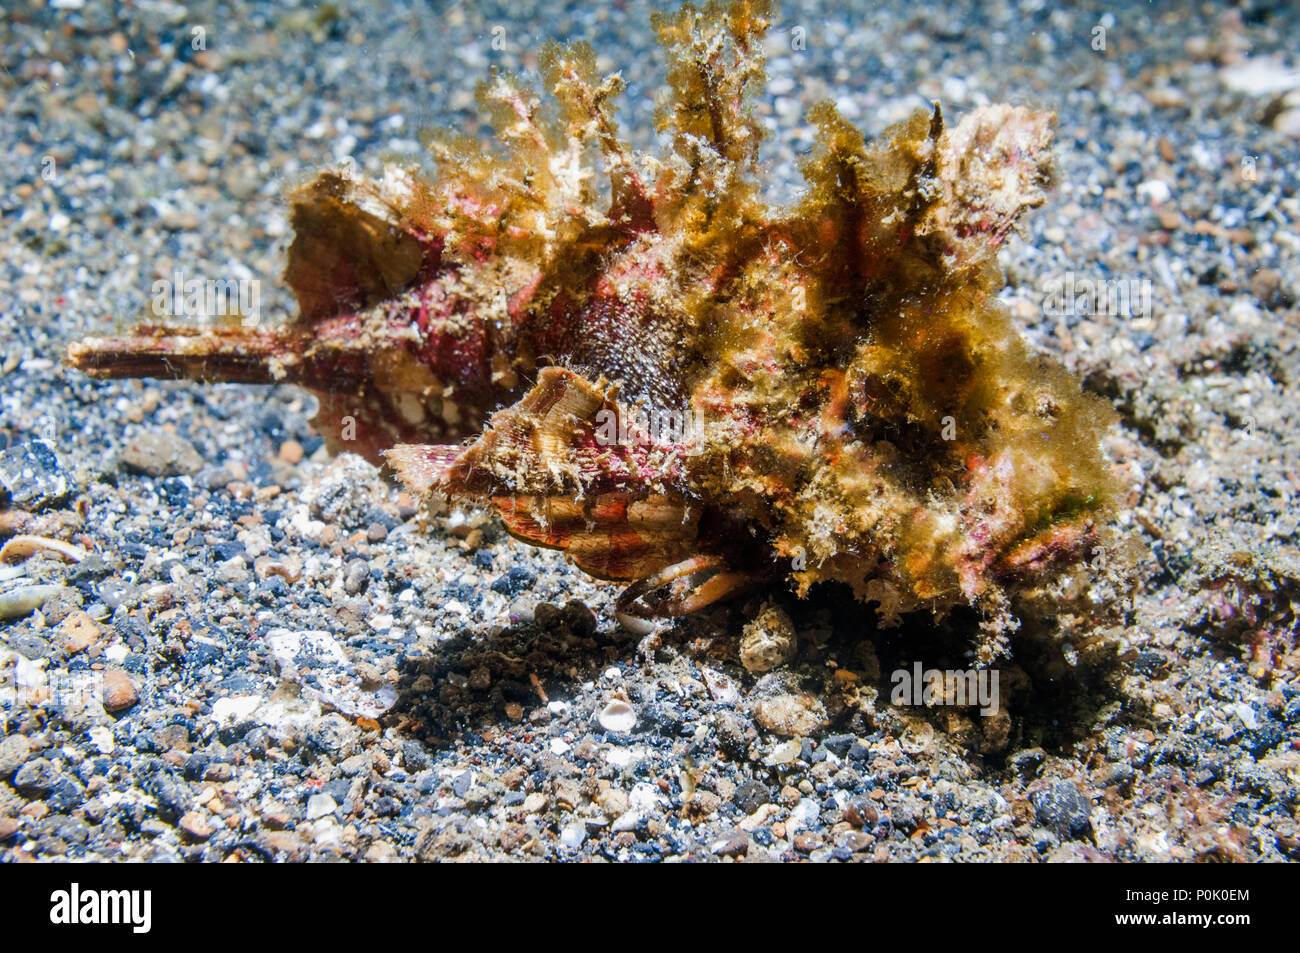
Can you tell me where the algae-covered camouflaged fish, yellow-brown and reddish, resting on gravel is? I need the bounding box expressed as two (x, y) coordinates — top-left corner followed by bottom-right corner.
(69, 0), (1113, 658)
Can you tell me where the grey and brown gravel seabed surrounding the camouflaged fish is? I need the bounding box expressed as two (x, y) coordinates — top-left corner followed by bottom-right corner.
(0, 0), (1300, 862)
